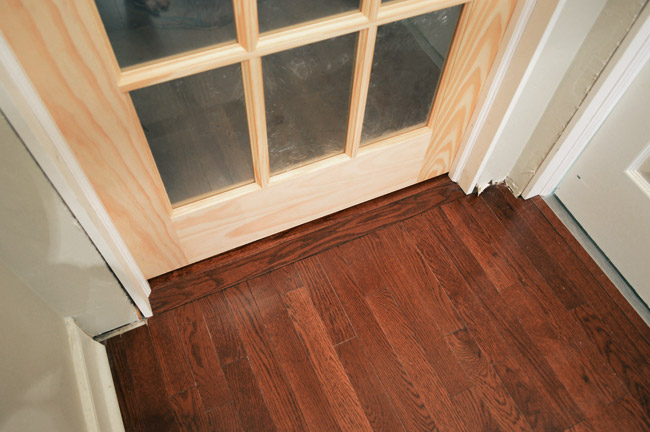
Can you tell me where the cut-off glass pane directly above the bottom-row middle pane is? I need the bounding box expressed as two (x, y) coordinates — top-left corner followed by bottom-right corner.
(251, 0), (359, 33)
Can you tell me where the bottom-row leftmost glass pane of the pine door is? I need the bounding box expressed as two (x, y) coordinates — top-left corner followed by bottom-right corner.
(131, 64), (253, 205)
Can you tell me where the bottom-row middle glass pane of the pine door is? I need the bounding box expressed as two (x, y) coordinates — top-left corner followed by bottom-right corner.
(262, 34), (356, 174)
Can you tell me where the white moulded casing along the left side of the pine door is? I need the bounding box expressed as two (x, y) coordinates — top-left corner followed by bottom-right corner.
(0, 32), (152, 316)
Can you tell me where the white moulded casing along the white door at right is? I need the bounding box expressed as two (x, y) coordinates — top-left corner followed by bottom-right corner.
(522, 7), (650, 199)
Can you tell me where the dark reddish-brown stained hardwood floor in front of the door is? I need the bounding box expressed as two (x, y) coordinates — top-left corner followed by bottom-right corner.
(107, 181), (650, 432)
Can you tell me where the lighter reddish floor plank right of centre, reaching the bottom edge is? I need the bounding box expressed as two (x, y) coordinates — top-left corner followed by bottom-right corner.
(366, 288), (467, 431)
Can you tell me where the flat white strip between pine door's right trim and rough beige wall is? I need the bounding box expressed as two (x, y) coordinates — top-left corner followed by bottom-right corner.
(477, 0), (606, 190)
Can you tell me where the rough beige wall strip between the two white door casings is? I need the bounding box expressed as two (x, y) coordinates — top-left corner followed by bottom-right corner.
(506, 0), (647, 195)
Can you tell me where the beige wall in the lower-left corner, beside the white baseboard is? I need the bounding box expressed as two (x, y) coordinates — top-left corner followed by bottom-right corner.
(0, 260), (86, 432)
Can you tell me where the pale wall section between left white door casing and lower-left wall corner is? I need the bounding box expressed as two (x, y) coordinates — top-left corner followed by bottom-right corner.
(0, 110), (138, 335)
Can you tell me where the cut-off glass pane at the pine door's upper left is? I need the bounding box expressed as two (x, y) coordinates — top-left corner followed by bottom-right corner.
(95, 0), (236, 67)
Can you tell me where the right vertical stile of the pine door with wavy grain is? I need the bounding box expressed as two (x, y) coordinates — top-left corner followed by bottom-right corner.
(419, 0), (516, 180)
